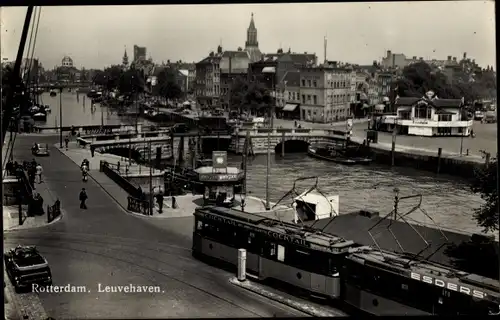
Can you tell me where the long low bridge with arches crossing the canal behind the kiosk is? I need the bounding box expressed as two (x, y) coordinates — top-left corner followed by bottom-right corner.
(78, 124), (345, 159)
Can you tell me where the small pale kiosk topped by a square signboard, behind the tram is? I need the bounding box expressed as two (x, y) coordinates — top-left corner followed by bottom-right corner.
(196, 151), (244, 206)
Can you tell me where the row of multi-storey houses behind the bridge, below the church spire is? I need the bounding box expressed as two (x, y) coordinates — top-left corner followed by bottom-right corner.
(194, 46), (394, 123)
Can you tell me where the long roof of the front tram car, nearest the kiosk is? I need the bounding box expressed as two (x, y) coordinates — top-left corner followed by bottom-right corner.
(196, 207), (356, 253)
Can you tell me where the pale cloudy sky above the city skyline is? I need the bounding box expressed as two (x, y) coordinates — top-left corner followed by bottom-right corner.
(1, 1), (496, 69)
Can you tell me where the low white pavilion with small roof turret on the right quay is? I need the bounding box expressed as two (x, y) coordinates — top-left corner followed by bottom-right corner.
(394, 91), (473, 137)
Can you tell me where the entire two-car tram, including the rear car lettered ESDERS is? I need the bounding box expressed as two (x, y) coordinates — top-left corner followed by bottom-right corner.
(193, 207), (500, 315)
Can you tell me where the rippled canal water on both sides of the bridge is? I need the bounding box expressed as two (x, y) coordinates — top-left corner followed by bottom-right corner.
(42, 92), (488, 238)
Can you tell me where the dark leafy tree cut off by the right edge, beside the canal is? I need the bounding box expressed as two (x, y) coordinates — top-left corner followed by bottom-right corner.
(471, 159), (499, 232)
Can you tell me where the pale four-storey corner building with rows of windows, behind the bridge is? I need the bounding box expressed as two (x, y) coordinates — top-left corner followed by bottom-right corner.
(300, 67), (351, 123)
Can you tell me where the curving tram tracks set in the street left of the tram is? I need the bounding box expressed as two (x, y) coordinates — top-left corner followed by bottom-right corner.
(5, 237), (307, 317)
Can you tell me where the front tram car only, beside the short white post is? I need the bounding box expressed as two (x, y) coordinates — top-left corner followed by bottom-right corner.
(192, 207), (354, 298)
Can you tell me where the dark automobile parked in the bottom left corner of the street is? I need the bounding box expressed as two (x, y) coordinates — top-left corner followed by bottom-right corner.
(4, 246), (52, 292)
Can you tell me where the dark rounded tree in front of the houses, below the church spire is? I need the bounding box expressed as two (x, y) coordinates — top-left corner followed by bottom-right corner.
(230, 77), (273, 114)
